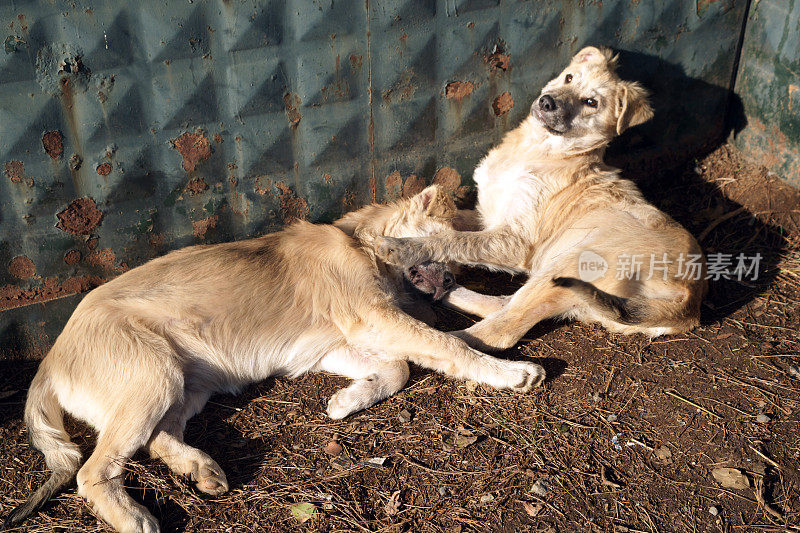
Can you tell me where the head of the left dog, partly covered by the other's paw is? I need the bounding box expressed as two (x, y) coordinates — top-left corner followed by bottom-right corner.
(334, 185), (458, 300)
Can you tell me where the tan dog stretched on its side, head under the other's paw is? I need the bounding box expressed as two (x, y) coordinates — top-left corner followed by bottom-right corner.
(5, 187), (544, 533)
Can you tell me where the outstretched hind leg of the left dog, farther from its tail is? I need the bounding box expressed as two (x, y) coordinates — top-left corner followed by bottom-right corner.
(147, 388), (228, 496)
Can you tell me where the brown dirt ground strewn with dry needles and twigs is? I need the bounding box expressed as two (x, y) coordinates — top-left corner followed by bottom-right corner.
(0, 146), (800, 532)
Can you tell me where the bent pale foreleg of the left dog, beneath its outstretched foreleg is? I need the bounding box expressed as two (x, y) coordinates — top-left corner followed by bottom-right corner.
(314, 347), (409, 419)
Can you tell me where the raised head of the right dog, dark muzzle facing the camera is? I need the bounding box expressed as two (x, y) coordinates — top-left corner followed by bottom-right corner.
(531, 46), (653, 151)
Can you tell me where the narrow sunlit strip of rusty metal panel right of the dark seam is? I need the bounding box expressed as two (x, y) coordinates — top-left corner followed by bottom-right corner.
(736, 0), (800, 186)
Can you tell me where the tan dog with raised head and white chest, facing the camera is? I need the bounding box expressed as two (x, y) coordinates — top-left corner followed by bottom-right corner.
(375, 47), (706, 349)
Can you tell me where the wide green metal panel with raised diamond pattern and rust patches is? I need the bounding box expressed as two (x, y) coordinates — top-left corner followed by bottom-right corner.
(0, 0), (745, 357)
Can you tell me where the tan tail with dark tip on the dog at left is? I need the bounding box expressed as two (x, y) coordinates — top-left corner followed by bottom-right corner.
(2, 367), (81, 529)
